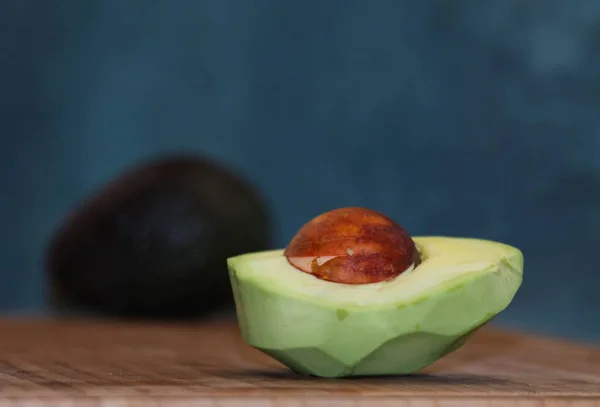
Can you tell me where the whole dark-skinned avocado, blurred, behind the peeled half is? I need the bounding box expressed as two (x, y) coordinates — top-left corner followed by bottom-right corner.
(46, 156), (270, 319)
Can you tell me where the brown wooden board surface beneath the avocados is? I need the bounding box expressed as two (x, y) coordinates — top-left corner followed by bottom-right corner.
(0, 320), (600, 407)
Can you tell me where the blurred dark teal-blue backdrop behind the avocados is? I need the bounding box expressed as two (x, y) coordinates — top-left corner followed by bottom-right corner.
(0, 0), (600, 341)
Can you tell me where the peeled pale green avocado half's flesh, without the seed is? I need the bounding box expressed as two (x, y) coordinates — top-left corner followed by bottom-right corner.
(227, 236), (523, 377)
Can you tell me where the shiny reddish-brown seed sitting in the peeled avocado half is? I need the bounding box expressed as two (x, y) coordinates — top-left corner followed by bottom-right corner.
(284, 208), (421, 284)
